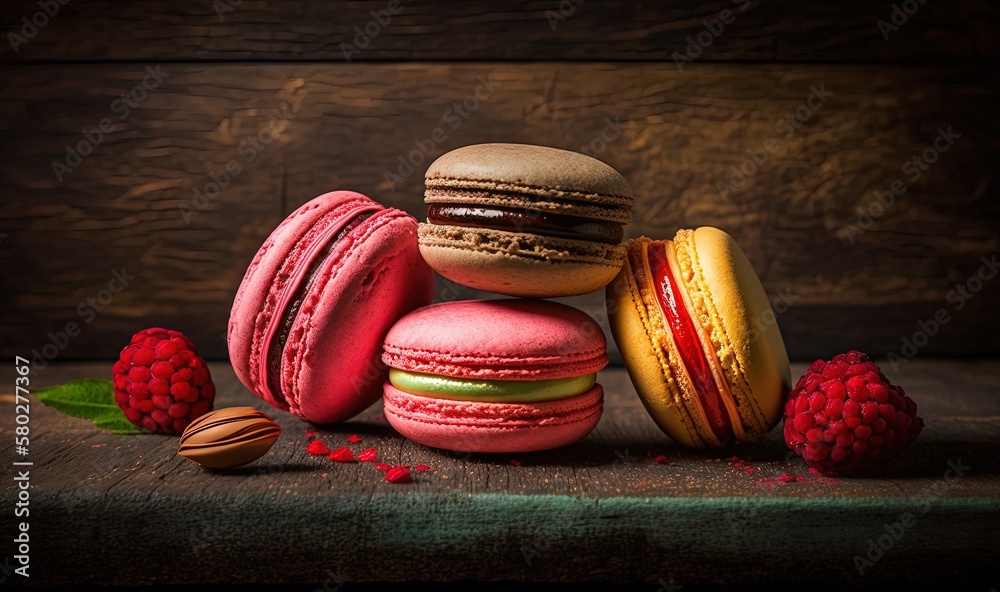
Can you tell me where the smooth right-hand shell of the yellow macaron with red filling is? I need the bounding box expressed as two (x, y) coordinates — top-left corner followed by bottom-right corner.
(693, 227), (791, 436)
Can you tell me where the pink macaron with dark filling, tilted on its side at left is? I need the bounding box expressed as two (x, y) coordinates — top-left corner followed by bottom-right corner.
(227, 191), (434, 424)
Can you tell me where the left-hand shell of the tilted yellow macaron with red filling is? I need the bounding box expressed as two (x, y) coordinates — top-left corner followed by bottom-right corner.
(605, 254), (708, 448)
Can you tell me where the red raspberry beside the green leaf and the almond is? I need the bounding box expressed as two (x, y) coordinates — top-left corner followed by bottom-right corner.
(112, 327), (215, 435)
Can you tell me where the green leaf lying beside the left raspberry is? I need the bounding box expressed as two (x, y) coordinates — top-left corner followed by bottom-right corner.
(33, 378), (146, 434)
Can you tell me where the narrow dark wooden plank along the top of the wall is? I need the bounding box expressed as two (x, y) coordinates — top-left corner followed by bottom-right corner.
(0, 0), (1000, 62)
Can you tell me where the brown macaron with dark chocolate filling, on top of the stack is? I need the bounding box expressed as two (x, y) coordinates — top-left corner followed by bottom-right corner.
(419, 143), (633, 298)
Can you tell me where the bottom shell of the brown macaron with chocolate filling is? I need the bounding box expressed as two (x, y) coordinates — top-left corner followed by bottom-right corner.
(419, 223), (625, 298)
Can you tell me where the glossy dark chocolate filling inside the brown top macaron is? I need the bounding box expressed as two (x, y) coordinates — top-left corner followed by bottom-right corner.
(427, 204), (624, 245)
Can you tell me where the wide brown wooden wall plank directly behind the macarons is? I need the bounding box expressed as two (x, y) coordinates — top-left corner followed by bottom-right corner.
(0, 63), (1000, 359)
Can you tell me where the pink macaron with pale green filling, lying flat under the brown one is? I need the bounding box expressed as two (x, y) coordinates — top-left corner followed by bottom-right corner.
(382, 298), (608, 452)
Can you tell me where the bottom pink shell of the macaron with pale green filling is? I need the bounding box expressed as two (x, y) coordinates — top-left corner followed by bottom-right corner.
(383, 383), (604, 453)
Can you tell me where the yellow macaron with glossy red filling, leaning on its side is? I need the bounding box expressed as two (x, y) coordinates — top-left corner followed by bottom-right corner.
(605, 227), (791, 448)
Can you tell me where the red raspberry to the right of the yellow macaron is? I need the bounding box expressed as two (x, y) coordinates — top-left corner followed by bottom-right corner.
(784, 351), (924, 475)
